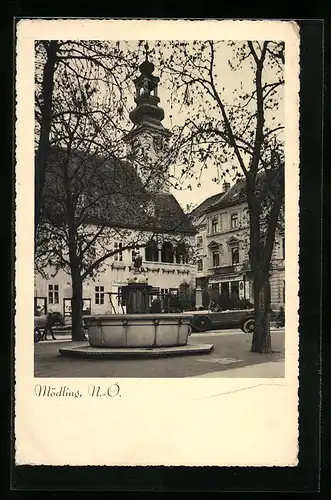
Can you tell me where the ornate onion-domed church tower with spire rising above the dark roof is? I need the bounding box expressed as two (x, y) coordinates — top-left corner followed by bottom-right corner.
(125, 44), (171, 193)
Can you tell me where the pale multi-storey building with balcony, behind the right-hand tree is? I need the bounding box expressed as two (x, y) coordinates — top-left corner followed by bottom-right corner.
(191, 181), (285, 310)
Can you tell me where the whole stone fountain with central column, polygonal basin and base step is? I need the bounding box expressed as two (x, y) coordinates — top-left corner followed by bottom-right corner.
(59, 256), (213, 358)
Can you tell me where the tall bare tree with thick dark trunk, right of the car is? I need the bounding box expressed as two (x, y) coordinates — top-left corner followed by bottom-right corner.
(154, 40), (284, 353)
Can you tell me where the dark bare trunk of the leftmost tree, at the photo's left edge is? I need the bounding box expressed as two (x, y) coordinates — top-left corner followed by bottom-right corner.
(35, 40), (58, 232)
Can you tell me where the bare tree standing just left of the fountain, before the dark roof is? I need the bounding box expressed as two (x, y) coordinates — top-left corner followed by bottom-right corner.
(35, 145), (192, 340)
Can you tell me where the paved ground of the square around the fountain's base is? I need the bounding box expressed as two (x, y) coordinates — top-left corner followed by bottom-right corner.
(35, 330), (285, 378)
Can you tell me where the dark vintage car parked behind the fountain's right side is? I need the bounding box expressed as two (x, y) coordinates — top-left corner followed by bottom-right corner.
(187, 309), (255, 333)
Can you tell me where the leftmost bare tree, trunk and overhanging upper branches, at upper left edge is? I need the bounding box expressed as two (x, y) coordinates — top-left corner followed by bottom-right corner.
(35, 40), (136, 232)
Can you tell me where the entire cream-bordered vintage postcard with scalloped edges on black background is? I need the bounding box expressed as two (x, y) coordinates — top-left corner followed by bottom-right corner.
(14, 19), (300, 467)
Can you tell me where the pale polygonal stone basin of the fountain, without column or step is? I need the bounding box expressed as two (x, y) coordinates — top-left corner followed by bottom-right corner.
(84, 313), (192, 347)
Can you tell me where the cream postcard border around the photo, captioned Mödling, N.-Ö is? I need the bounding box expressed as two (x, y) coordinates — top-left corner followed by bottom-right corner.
(15, 19), (299, 466)
